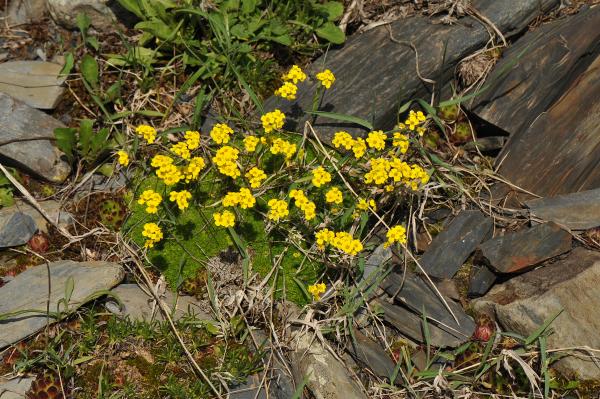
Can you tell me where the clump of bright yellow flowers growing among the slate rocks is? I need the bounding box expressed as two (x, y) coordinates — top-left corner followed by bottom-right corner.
(118, 66), (430, 301)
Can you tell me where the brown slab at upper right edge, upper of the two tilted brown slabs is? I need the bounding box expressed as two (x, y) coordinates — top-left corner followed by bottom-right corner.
(471, 7), (600, 138)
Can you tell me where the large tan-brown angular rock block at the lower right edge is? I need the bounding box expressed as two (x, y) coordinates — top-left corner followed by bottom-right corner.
(472, 248), (600, 381)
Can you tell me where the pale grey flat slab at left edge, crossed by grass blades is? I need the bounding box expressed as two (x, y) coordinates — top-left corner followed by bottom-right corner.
(0, 260), (124, 349)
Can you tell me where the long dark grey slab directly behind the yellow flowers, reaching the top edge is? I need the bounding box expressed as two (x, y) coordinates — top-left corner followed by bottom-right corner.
(265, 0), (559, 140)
